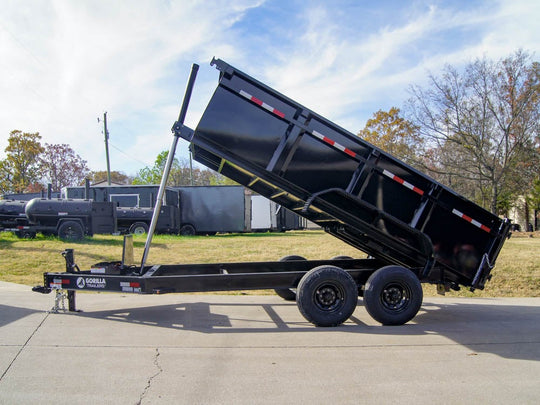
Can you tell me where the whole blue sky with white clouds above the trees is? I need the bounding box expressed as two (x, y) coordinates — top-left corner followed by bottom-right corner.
(0, 0), (540, 175)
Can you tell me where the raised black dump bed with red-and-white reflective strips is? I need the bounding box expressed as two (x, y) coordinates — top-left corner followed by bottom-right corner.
(177, 60), (510, 288)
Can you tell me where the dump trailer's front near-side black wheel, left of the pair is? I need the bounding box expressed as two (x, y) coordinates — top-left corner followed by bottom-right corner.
(296, 266), (358, 326)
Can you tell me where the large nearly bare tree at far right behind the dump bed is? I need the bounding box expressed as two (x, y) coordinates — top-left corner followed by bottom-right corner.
(407, 51), (540, 213)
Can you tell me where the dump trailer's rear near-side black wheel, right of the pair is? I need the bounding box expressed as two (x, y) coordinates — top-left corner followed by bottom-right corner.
(364, 266), (423, 325)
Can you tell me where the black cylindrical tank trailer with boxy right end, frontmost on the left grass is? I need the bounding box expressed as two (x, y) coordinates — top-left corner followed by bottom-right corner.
(11, 198), (116, 240)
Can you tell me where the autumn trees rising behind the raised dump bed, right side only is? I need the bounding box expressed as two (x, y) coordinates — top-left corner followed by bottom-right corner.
(359, 50), (540, 217)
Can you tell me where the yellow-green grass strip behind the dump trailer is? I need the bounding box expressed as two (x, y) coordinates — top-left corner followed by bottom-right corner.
(0, 231), (540, 297)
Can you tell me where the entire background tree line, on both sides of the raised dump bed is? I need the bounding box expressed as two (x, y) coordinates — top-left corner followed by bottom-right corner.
(0, 50), (540, 221)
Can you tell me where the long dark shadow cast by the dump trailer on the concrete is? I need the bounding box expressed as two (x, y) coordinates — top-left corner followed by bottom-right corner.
(69, 300), (540, 361)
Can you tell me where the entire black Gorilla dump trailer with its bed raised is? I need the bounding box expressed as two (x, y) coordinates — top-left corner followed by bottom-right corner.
(36, 60), (510, 326)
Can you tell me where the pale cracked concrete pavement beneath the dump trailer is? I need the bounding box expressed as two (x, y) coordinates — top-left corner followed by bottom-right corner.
(0, 282), (540, 404)
